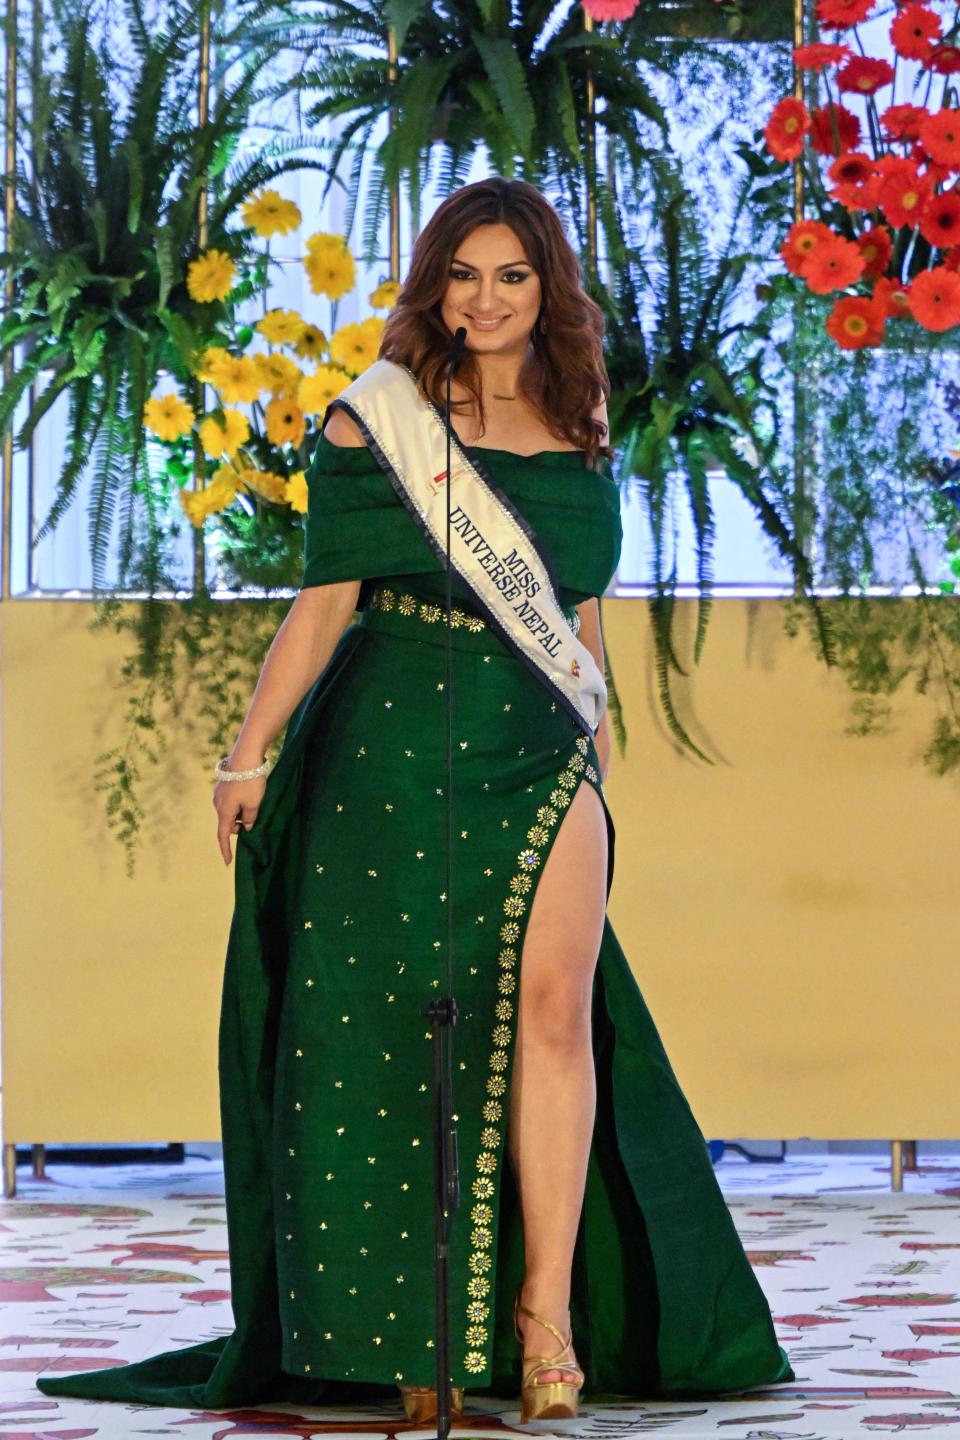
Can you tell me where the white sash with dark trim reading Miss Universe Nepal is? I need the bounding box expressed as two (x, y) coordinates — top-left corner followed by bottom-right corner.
(324, 360), (607, 736)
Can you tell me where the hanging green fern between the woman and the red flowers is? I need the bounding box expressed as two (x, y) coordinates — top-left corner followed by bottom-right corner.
(604, 163), (833, 763)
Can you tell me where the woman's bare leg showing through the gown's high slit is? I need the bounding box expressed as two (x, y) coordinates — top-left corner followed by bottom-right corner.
(507, 780), (607, 1381)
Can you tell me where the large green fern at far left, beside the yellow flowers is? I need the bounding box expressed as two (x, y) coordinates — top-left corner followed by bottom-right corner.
(0, 0), (325, 593)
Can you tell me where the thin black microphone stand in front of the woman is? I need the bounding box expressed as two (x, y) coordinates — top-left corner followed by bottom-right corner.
(420, 325), (466, 1440)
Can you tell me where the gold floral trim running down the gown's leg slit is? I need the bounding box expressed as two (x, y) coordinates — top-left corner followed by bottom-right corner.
(463, 736), (596, 1375)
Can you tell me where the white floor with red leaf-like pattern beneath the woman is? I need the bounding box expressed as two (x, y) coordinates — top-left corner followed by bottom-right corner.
(0, 1145), (960, 1440)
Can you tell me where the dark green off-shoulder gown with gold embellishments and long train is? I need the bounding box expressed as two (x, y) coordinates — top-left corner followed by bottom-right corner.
(37, 436), (794, 1407)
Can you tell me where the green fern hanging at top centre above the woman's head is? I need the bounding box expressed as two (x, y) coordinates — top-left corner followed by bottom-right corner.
(231, 0), (666, 259)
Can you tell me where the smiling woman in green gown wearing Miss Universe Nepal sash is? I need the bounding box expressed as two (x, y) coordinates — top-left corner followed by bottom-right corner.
(37, 177), (794, 1420)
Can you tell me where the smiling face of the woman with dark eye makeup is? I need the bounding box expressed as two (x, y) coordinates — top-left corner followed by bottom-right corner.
(440, 223), (541, 356)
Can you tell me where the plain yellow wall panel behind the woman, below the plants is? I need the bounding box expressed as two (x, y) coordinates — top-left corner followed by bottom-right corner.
(0, 599), (960, 1143)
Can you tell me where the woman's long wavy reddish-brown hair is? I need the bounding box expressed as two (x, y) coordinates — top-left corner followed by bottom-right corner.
(379, 176), (613, 459)
